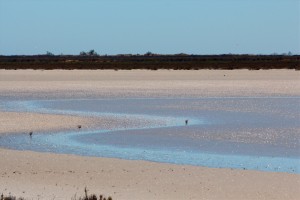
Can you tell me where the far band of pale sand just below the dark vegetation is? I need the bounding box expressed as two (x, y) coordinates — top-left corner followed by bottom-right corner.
(0, 70), (300, 99)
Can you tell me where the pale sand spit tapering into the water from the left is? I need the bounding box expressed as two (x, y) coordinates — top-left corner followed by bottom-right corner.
(0, 109), (164, 135)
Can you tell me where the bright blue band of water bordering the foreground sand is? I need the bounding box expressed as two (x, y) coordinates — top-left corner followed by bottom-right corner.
(0, 130), (300, 174)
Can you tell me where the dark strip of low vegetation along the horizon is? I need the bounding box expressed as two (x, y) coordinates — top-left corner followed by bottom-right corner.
(0, 52), (300, 70)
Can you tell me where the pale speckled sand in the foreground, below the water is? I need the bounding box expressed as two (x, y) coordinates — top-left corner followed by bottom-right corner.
(0, 149), (300, 200)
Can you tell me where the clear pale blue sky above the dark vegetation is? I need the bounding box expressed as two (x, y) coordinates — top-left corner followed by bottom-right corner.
(0, 0), (300, 55)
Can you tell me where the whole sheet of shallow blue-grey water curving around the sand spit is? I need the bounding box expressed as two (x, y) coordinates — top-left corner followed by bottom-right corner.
(0, 97), (300, 173)
